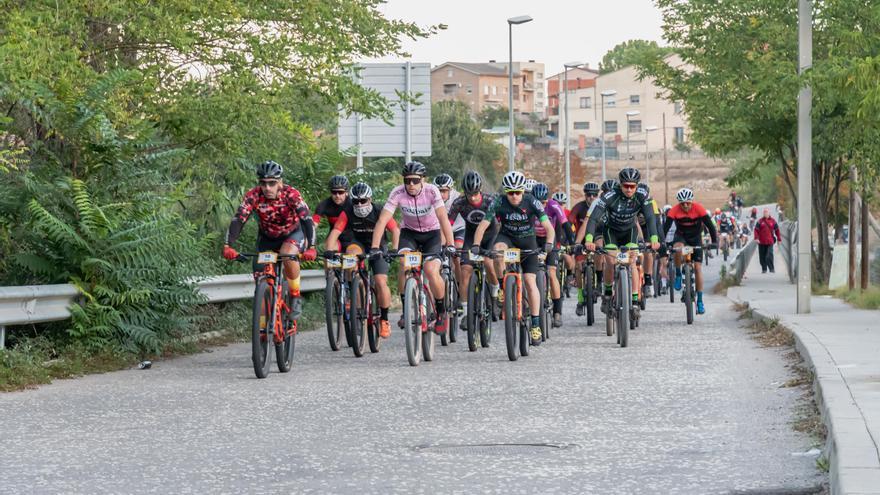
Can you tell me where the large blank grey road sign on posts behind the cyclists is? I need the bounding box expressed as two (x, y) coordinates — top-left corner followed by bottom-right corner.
(338, 63), (431, 157)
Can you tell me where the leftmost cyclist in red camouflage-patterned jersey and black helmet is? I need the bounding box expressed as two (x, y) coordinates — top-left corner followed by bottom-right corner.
(223, 160), (317, 318)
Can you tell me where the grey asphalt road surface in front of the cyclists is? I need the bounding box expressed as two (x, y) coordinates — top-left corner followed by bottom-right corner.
(0, 265), (824, 494)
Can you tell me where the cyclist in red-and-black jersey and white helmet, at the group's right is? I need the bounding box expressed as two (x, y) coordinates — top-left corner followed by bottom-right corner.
(663, 187), (718, 315)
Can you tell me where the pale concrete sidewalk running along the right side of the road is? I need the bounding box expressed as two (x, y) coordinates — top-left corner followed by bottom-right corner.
(727, 246), (880, 495)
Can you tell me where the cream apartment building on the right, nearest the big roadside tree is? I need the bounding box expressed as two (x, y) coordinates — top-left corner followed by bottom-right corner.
(554, 55), (690, 156)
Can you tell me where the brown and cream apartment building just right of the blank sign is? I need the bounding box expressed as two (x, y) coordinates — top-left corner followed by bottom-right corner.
(431, 60), (546, 115)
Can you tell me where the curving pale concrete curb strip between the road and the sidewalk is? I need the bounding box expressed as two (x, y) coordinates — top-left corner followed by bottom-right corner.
(727, 287), (880, 495)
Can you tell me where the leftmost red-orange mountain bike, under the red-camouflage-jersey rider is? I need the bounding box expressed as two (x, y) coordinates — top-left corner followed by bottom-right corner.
(236, 251), (299, 378)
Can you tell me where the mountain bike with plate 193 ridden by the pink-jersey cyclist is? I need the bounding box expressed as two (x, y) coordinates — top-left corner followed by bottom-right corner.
(389, 251), (443, 366)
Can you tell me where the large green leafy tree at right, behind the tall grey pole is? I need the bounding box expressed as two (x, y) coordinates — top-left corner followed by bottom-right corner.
(639, 0), (878, 283)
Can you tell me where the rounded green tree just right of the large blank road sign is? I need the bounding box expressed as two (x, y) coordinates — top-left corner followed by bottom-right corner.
(424, 101), (503, 184)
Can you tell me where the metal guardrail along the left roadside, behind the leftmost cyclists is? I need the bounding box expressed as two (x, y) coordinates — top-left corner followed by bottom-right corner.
(0, 270), (325, 349)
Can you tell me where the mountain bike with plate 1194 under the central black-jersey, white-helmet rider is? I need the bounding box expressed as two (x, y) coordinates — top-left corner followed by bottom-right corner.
(491, 248), (540, 361)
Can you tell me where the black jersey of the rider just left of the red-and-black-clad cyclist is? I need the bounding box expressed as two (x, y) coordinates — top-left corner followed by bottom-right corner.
(587, 186), (658, 242)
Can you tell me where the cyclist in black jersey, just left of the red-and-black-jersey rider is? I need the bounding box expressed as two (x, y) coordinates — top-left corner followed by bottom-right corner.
(584, 167), (660, 314)
